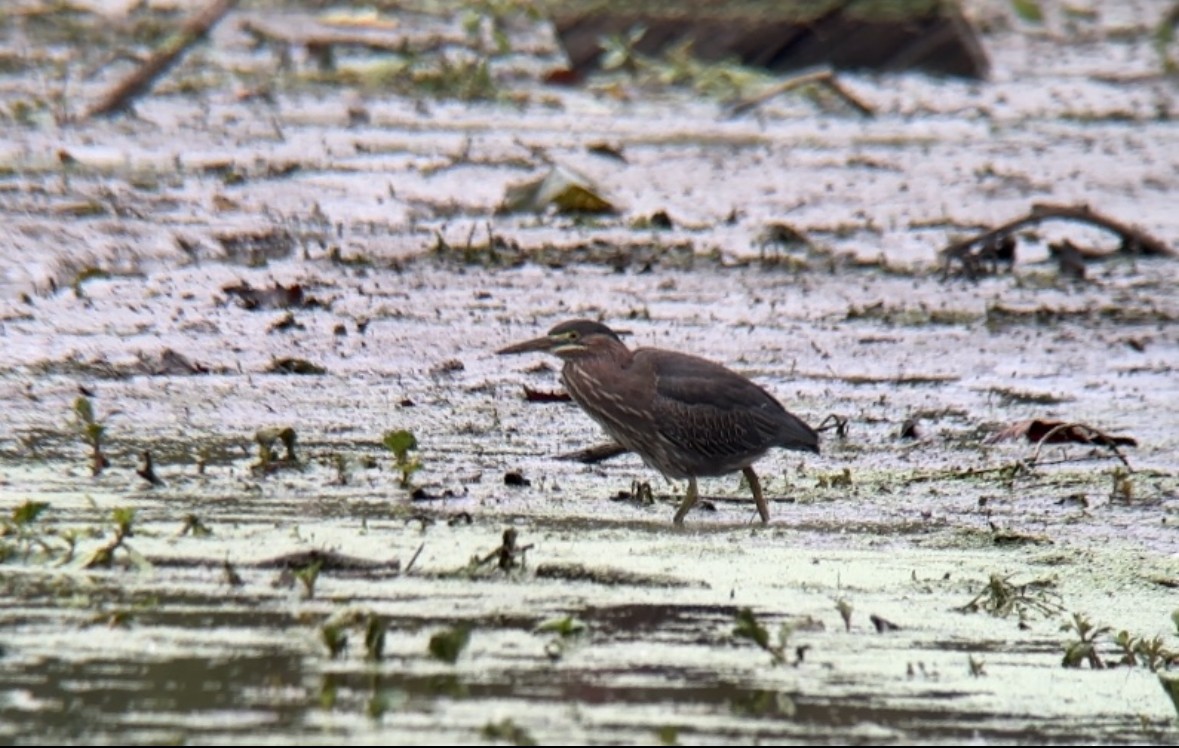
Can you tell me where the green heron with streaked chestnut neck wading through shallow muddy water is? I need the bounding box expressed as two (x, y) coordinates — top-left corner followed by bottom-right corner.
(498, 320), (818, 525)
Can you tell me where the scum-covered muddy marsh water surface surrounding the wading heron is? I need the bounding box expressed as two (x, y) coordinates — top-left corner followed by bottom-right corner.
(0, 2), (1179, 744)
